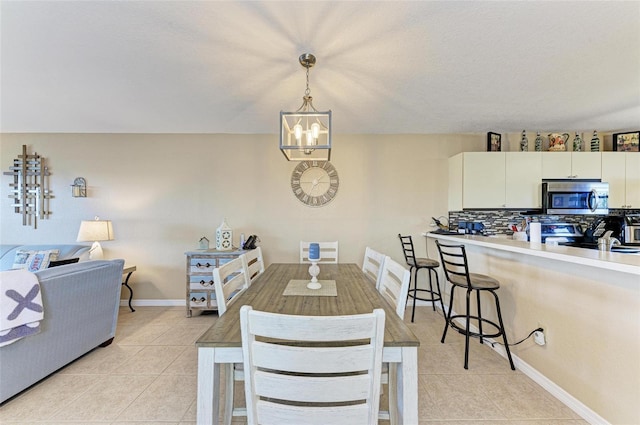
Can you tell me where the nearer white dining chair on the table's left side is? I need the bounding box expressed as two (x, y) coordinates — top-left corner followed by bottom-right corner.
(213, 254), (249, 425)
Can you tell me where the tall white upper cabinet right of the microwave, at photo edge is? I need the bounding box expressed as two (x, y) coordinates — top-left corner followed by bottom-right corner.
(602, 152), (640, 208)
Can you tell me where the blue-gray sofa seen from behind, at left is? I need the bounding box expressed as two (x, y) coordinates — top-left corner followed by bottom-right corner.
(0, 253), (124, 403)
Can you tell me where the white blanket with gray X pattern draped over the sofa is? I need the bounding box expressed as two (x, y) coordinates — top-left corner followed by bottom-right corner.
(0, 270), (44, 347)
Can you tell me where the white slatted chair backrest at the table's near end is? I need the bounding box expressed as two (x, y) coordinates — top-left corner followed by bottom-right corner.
(240, 305), (385, 425)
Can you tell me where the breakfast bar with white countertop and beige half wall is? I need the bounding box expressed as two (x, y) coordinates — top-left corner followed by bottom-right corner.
(423, 233), (640, 424)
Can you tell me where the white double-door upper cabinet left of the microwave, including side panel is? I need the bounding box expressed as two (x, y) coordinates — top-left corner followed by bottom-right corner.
(449, 152), (542, 211)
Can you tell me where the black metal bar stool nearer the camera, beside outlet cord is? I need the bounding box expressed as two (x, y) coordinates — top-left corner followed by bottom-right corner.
(436, 240), (516, 370)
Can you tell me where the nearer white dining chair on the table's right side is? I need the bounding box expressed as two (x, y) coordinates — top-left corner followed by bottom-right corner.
(378, 253), (411, 424)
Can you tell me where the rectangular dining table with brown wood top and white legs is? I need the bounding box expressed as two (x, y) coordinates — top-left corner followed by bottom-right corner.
(196, 264), (420, 425)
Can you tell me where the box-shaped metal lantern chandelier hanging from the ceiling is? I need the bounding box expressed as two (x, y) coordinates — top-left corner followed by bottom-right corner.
(280, 53), (331, 161)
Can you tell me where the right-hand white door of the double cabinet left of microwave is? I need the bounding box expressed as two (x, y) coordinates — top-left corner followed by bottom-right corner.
(505, 152), (542, 208)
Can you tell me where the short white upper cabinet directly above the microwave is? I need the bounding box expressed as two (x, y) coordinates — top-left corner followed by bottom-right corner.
(542, 152), (602, 179)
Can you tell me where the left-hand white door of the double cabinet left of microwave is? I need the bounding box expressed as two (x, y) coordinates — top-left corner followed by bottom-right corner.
(462, 152), (505, 208)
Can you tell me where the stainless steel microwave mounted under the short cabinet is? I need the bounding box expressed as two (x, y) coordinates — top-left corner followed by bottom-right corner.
(542, 180), (609, 214)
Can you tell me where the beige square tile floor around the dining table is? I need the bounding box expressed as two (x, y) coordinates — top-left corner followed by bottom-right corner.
(0, 307), (586, 425)
